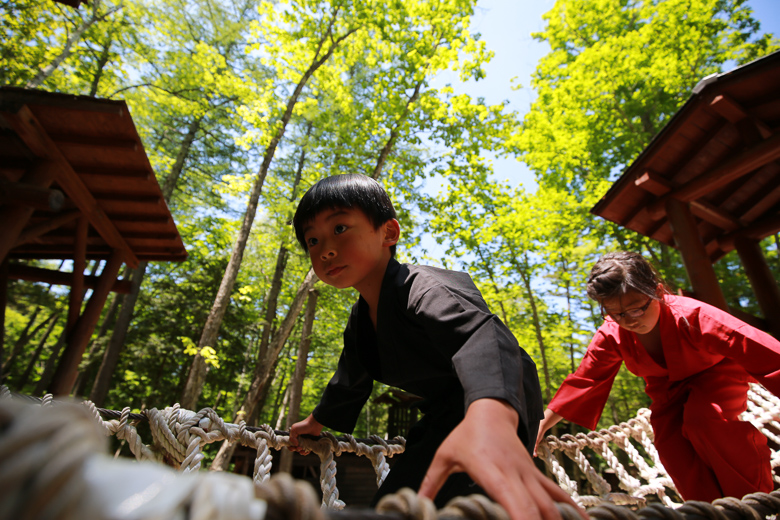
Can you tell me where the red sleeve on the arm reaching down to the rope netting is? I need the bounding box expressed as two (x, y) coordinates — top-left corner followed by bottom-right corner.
(548, 326), (623, 430)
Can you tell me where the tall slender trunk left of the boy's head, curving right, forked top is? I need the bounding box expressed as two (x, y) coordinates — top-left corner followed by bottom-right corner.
(180, 17), (357, 409)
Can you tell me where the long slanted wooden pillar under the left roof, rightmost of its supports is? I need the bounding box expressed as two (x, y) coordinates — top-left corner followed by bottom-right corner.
(51, 250), (124, 395)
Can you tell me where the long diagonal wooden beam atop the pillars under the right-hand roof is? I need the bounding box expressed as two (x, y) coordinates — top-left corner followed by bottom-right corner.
(648, 134), (780, 219)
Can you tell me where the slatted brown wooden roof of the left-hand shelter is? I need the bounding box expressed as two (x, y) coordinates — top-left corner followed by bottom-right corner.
(0, 87), (187, 267)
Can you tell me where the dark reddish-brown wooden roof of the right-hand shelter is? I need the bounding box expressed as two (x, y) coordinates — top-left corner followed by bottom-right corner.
(591, 51), (780, 261)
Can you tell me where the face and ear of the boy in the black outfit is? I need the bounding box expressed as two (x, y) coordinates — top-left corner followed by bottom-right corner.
(303, 208), (399, 293)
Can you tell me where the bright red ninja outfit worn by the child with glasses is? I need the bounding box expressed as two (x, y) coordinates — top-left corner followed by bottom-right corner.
(549, 295), (780, 502)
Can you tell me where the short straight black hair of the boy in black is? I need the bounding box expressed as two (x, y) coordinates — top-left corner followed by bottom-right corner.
(293, 173), (397, 257)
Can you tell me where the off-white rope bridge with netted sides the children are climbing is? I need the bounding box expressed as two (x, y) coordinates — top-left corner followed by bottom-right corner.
(0, 386), (780, 520)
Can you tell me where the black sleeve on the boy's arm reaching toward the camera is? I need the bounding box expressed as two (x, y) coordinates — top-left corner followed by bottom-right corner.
(410, 280), (542, 445)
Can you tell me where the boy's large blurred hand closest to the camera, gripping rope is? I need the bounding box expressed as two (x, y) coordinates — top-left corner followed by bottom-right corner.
(419, 399), (588, 520)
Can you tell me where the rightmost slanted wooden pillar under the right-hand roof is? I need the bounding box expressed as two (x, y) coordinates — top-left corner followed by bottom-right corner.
(734, 236), (780, 338)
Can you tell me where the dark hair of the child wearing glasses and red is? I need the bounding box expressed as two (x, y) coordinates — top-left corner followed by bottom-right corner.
(587, 251), (668, 303)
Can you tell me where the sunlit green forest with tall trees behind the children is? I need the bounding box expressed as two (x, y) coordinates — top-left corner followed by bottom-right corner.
(0, 0), (780, 467)
